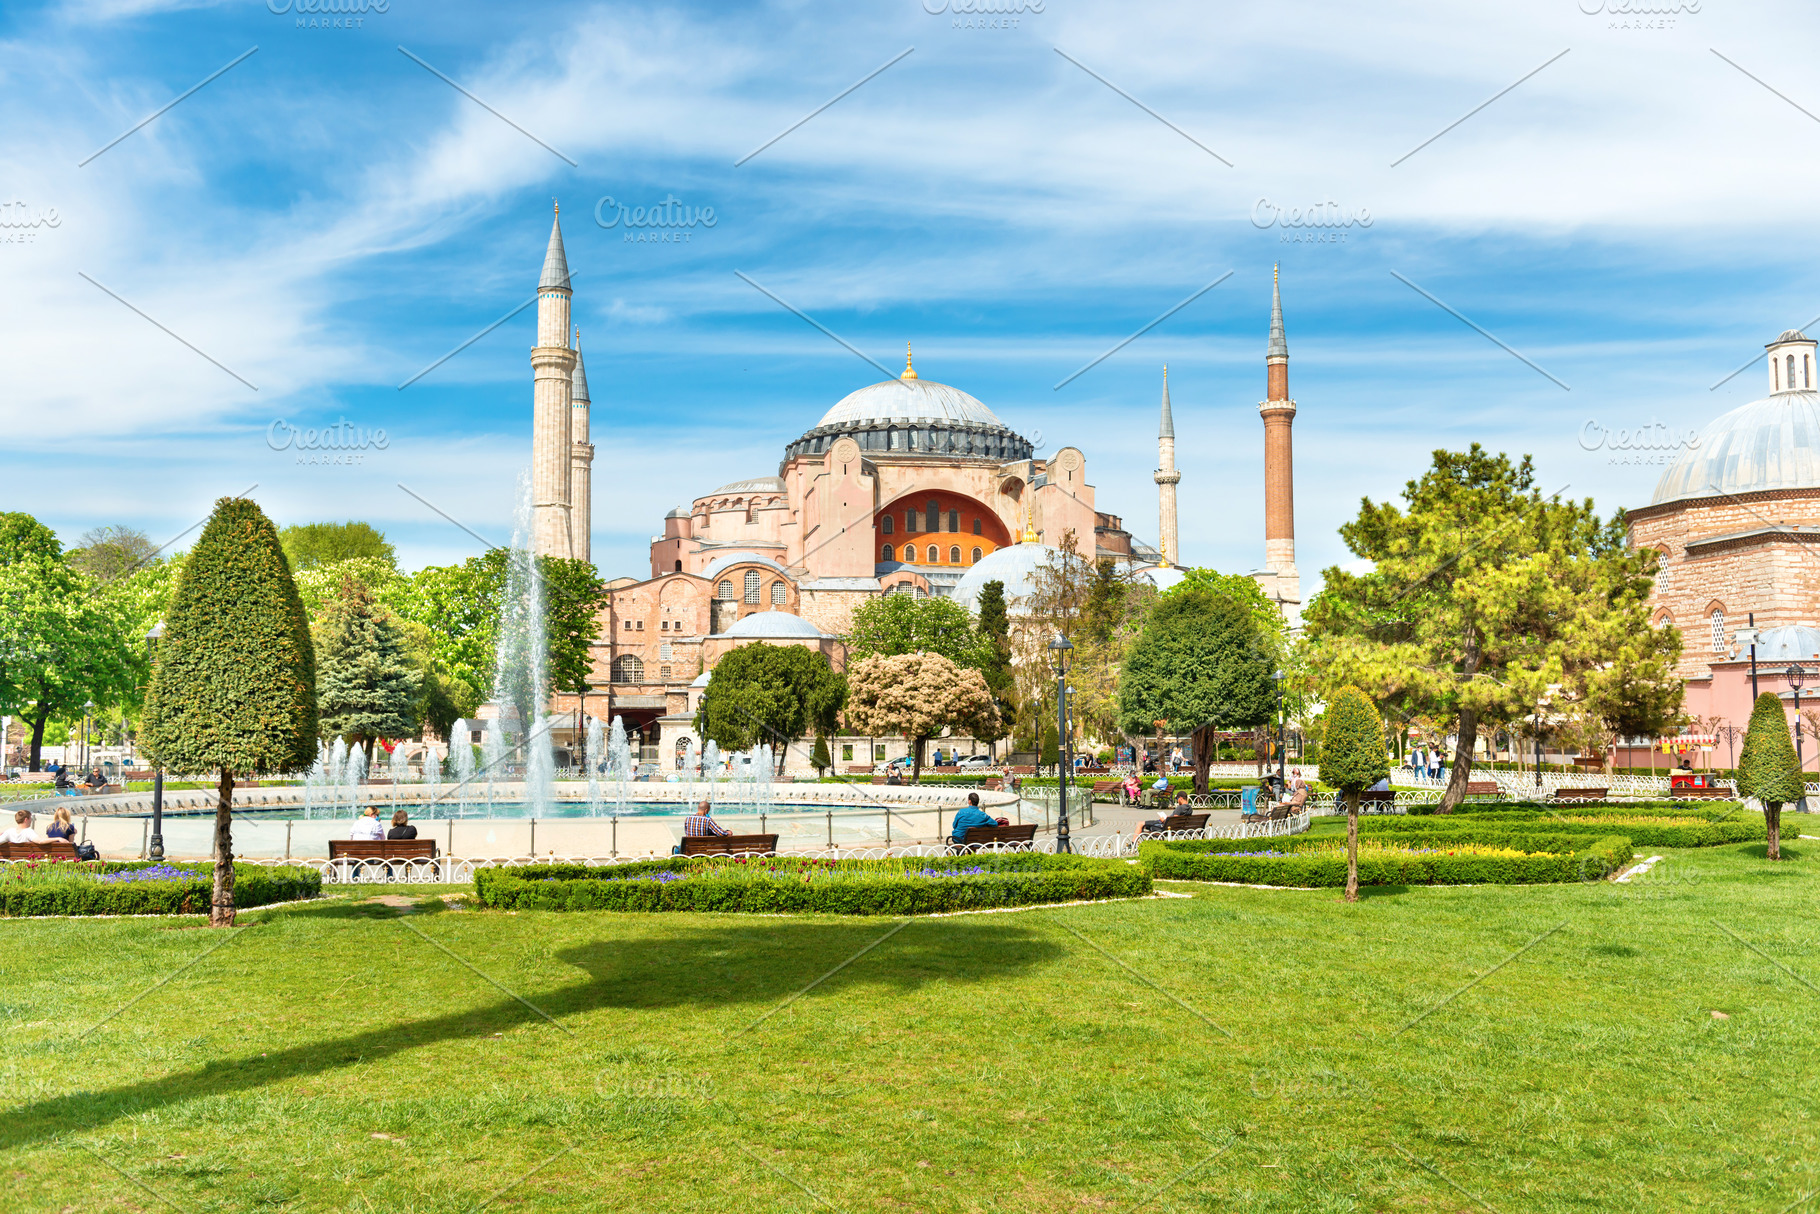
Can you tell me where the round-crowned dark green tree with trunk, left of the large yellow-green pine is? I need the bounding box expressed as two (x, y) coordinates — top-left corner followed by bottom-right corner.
(1119, 586), (1278, 792)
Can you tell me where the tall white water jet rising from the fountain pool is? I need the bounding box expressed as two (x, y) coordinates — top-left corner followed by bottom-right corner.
(493, 471), (555, 817)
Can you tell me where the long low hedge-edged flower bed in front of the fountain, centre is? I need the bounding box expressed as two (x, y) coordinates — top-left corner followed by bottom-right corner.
(473, 852), (1152, 916)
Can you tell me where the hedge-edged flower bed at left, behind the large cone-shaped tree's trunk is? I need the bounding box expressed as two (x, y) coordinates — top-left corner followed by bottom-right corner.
(0, 859), (322, 916)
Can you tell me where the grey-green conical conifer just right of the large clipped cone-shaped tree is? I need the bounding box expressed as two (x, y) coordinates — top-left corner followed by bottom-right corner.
(317, 577), (424, 760)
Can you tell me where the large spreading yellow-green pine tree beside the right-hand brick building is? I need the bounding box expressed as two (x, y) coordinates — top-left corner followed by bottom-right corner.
(1303, 444), (1682, 808)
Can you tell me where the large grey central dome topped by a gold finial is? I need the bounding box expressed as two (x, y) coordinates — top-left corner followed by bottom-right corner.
(784, 359), (1034, 460)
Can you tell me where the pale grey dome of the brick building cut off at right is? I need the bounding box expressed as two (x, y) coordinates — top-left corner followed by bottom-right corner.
(1649, 391), (1820, 506)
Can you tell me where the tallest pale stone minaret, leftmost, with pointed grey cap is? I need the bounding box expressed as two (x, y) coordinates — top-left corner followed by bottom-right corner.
(531, 202), (575, 557)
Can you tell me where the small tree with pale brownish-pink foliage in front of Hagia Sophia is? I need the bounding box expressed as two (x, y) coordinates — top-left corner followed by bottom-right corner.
(843, 653), (999, 781)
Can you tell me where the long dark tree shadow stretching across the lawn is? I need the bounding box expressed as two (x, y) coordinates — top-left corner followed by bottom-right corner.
(0, 917), (1067, 1150)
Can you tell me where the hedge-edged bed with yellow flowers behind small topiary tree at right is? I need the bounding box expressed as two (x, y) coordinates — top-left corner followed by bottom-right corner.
(1138, 834), (1631, 888)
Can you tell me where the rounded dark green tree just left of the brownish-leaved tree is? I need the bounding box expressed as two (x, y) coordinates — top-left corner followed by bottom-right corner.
(695, 644), (846, 770)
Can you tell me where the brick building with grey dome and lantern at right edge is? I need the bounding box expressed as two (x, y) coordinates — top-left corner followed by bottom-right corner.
(1629, 329), (1820, 726)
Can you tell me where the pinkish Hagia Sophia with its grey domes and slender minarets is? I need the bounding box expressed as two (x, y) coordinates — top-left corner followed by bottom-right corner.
(531, 206), (1299, 759)
